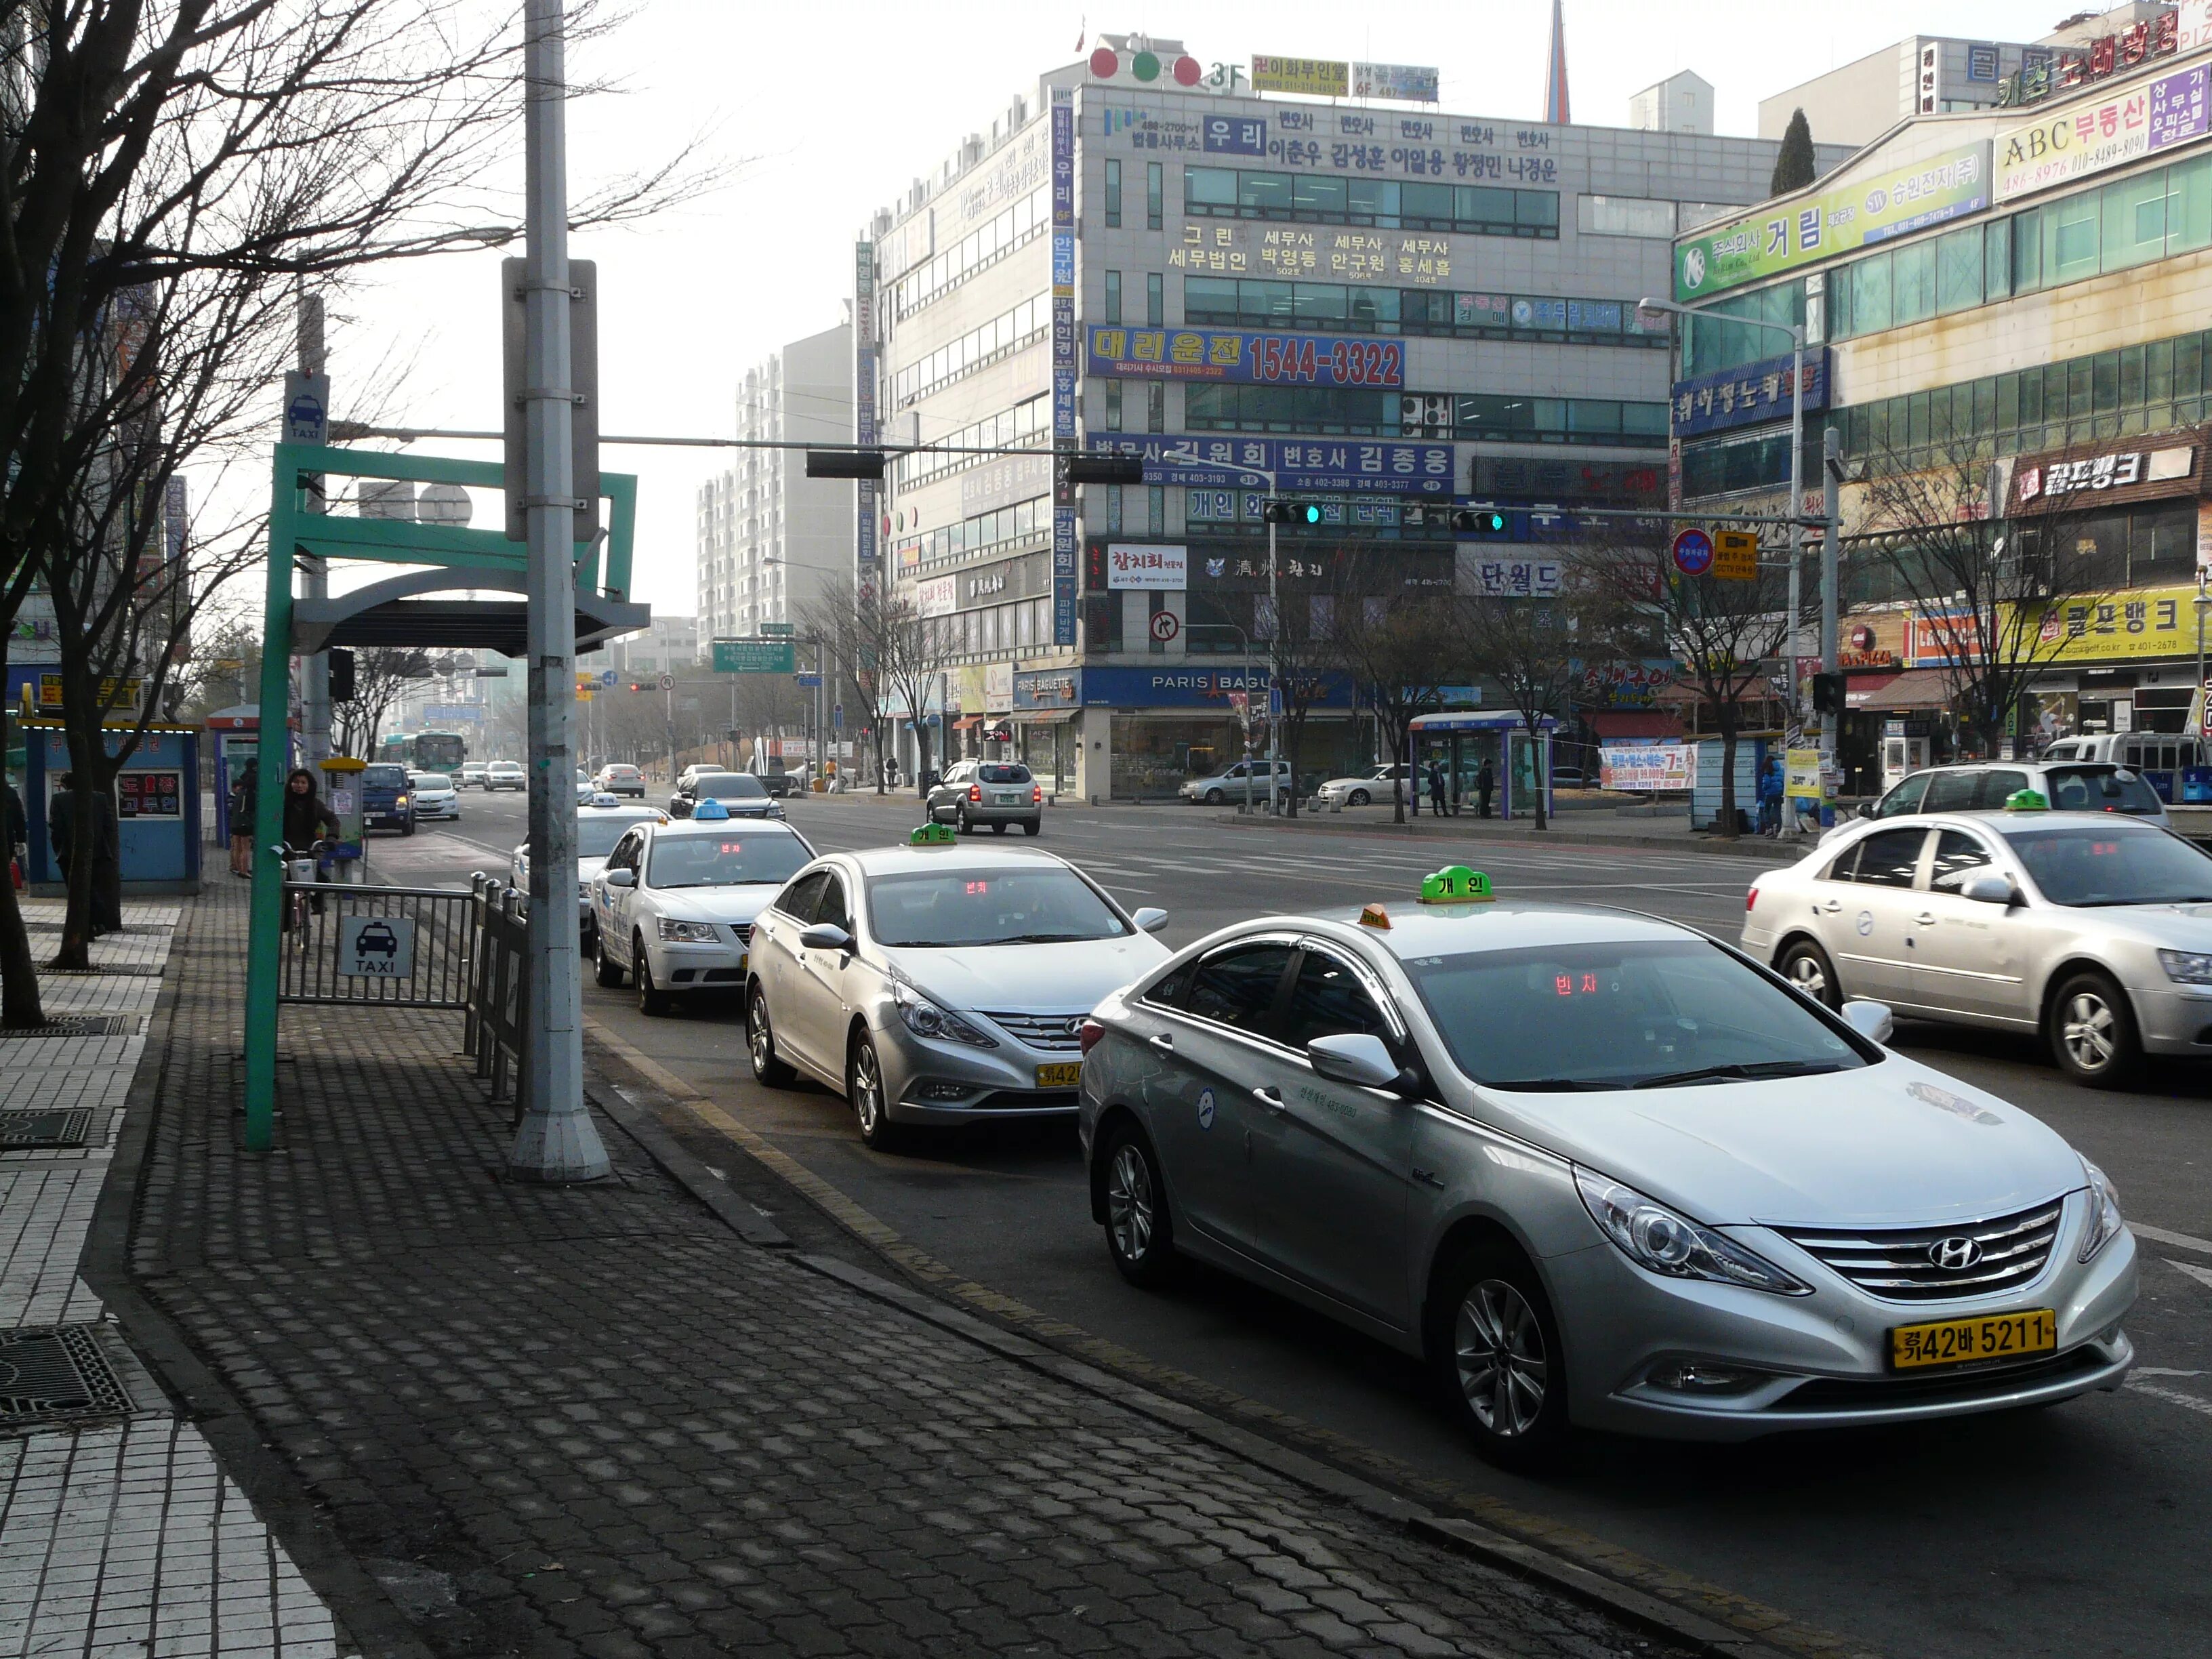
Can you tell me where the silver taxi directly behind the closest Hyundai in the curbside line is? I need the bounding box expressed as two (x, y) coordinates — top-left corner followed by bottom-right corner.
(745, 825), (1168, 1146)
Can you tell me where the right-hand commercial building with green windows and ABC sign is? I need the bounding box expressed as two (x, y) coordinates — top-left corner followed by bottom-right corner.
(1673, 0), (2212, 790)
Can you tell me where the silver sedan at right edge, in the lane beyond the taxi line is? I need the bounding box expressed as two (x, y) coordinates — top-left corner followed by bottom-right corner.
(1743, 810), (2212, 1088)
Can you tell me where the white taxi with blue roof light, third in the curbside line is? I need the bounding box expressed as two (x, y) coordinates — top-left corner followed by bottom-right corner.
(590, 798), (814, 1015)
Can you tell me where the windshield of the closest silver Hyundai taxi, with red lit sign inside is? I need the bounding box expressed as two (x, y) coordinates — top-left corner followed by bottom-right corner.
(1405, 938), (1867, 1090)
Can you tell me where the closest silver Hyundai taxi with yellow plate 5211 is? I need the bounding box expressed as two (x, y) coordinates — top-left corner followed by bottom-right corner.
(1082, 903), (2137, 1465)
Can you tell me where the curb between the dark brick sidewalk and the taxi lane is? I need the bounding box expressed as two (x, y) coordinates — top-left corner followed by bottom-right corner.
(586, 1015), (1871, 1659)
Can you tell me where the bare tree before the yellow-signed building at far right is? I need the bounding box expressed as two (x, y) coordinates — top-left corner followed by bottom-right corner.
(1843, 438), (2079, 756)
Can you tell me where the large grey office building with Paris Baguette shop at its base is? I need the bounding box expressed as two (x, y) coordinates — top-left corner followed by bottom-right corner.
(856, 37), (1845, 798)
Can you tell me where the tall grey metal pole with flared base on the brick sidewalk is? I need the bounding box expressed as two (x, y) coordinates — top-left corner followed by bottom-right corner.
(506, 0), (613, 1181)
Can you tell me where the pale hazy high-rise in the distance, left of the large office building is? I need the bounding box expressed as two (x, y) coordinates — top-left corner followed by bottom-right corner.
(697, 323), (854, 639)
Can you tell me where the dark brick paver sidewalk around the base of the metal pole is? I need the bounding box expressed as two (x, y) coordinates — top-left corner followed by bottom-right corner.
(112, 887), (1698, 1659)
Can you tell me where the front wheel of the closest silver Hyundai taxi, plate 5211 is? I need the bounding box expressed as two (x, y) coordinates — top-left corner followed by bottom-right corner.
(1429, 1239), (1568, 1469)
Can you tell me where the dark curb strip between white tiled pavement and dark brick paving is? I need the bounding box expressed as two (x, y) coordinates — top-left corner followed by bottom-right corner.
(77, 907), (434, 1659)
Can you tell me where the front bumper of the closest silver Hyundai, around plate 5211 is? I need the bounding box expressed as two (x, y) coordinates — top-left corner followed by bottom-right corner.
(1544, 1192), (2137, 1442)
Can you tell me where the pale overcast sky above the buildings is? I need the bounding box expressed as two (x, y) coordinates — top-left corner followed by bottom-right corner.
(298, 0), (2093, 615)
